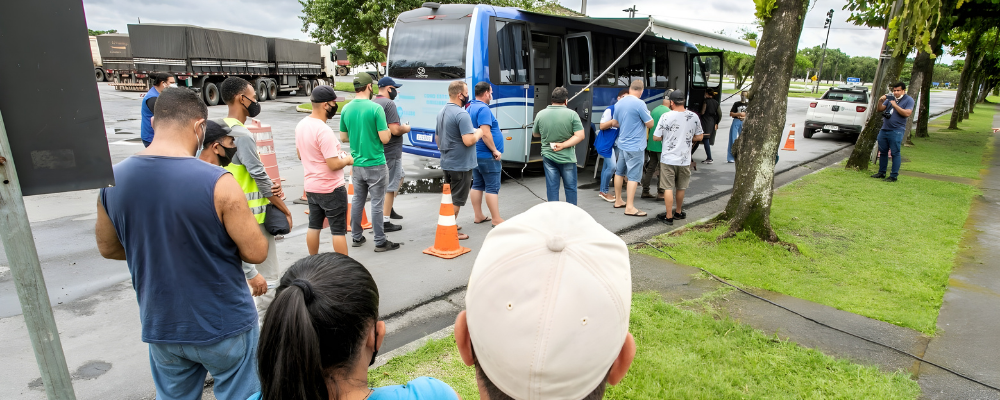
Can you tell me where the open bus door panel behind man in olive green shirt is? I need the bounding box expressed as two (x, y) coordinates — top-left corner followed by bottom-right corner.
(565, 32), (594, 168)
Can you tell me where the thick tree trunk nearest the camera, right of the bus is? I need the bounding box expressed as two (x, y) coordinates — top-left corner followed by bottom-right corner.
(719, 0), (809, 243)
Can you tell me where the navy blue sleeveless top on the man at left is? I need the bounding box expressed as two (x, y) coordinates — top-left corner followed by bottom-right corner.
(100, 156), (257, 345)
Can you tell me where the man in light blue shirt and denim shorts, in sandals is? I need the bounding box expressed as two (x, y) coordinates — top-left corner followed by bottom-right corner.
(612, 79), (654, 217)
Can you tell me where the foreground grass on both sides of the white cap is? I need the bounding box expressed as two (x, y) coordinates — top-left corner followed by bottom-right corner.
(369, 293), (920, 399)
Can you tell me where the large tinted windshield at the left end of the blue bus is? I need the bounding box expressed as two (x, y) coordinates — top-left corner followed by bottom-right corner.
(388, 18), (471, 79)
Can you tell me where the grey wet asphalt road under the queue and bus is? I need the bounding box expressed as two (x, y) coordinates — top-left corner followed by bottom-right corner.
(0, 84), (954, 399)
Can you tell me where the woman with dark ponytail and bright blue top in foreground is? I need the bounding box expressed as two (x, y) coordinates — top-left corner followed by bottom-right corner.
(249, 253), (458, 400)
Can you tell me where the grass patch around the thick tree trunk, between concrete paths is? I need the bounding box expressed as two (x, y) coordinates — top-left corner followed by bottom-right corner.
(644, 165), (978, 334)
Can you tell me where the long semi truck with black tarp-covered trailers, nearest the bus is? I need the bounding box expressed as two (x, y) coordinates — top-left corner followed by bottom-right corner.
(105, 24), (335, 106)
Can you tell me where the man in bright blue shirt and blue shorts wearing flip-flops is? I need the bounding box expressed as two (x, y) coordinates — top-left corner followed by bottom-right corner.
(468, 81), (503, 226)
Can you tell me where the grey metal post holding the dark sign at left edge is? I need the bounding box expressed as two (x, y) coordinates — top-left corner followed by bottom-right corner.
(0, 110), (76, 400)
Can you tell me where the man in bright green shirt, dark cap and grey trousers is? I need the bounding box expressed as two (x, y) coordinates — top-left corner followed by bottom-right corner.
(340, 72), (400, 252)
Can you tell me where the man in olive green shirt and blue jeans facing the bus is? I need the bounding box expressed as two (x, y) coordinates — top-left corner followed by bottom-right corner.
(531, 86), (584, 205)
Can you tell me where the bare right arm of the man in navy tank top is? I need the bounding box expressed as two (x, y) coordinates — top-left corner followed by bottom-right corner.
(215, 174), (267, 264)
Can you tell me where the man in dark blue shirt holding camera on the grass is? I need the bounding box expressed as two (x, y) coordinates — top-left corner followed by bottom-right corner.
(872, 82), (914, 182)
